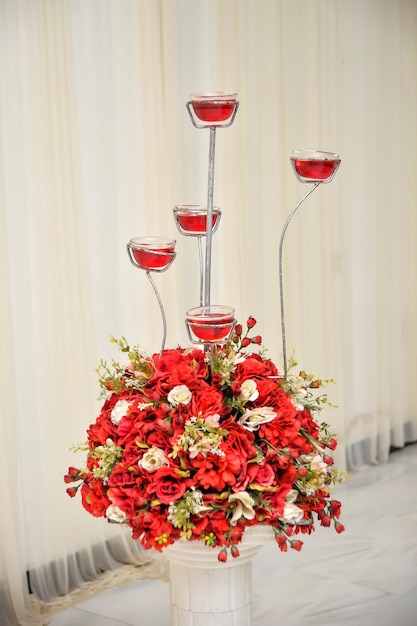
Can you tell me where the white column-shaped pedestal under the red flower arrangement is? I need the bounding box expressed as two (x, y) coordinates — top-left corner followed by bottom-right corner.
(164, 526), (274, 626)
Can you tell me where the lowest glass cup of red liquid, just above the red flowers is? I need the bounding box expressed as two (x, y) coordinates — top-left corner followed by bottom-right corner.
(186, 304), (236, 344)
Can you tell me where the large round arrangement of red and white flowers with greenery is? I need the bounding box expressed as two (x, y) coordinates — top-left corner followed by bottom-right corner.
(65, 317), (344, 561)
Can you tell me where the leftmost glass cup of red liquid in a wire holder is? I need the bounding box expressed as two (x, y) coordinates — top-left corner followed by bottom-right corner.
(127, 237), (176, 272)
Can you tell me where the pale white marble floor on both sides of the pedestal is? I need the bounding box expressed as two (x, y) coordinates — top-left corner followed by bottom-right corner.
(50, 444), (417, 626)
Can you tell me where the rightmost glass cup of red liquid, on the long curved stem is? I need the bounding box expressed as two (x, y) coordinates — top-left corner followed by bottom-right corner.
(290, 150), (340, 183)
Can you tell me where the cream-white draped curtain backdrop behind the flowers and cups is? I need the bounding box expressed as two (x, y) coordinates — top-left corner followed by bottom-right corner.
(0, 0), (417, 626)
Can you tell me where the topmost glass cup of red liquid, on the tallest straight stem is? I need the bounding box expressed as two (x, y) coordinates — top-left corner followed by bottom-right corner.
(187, 91), (239, 128)
